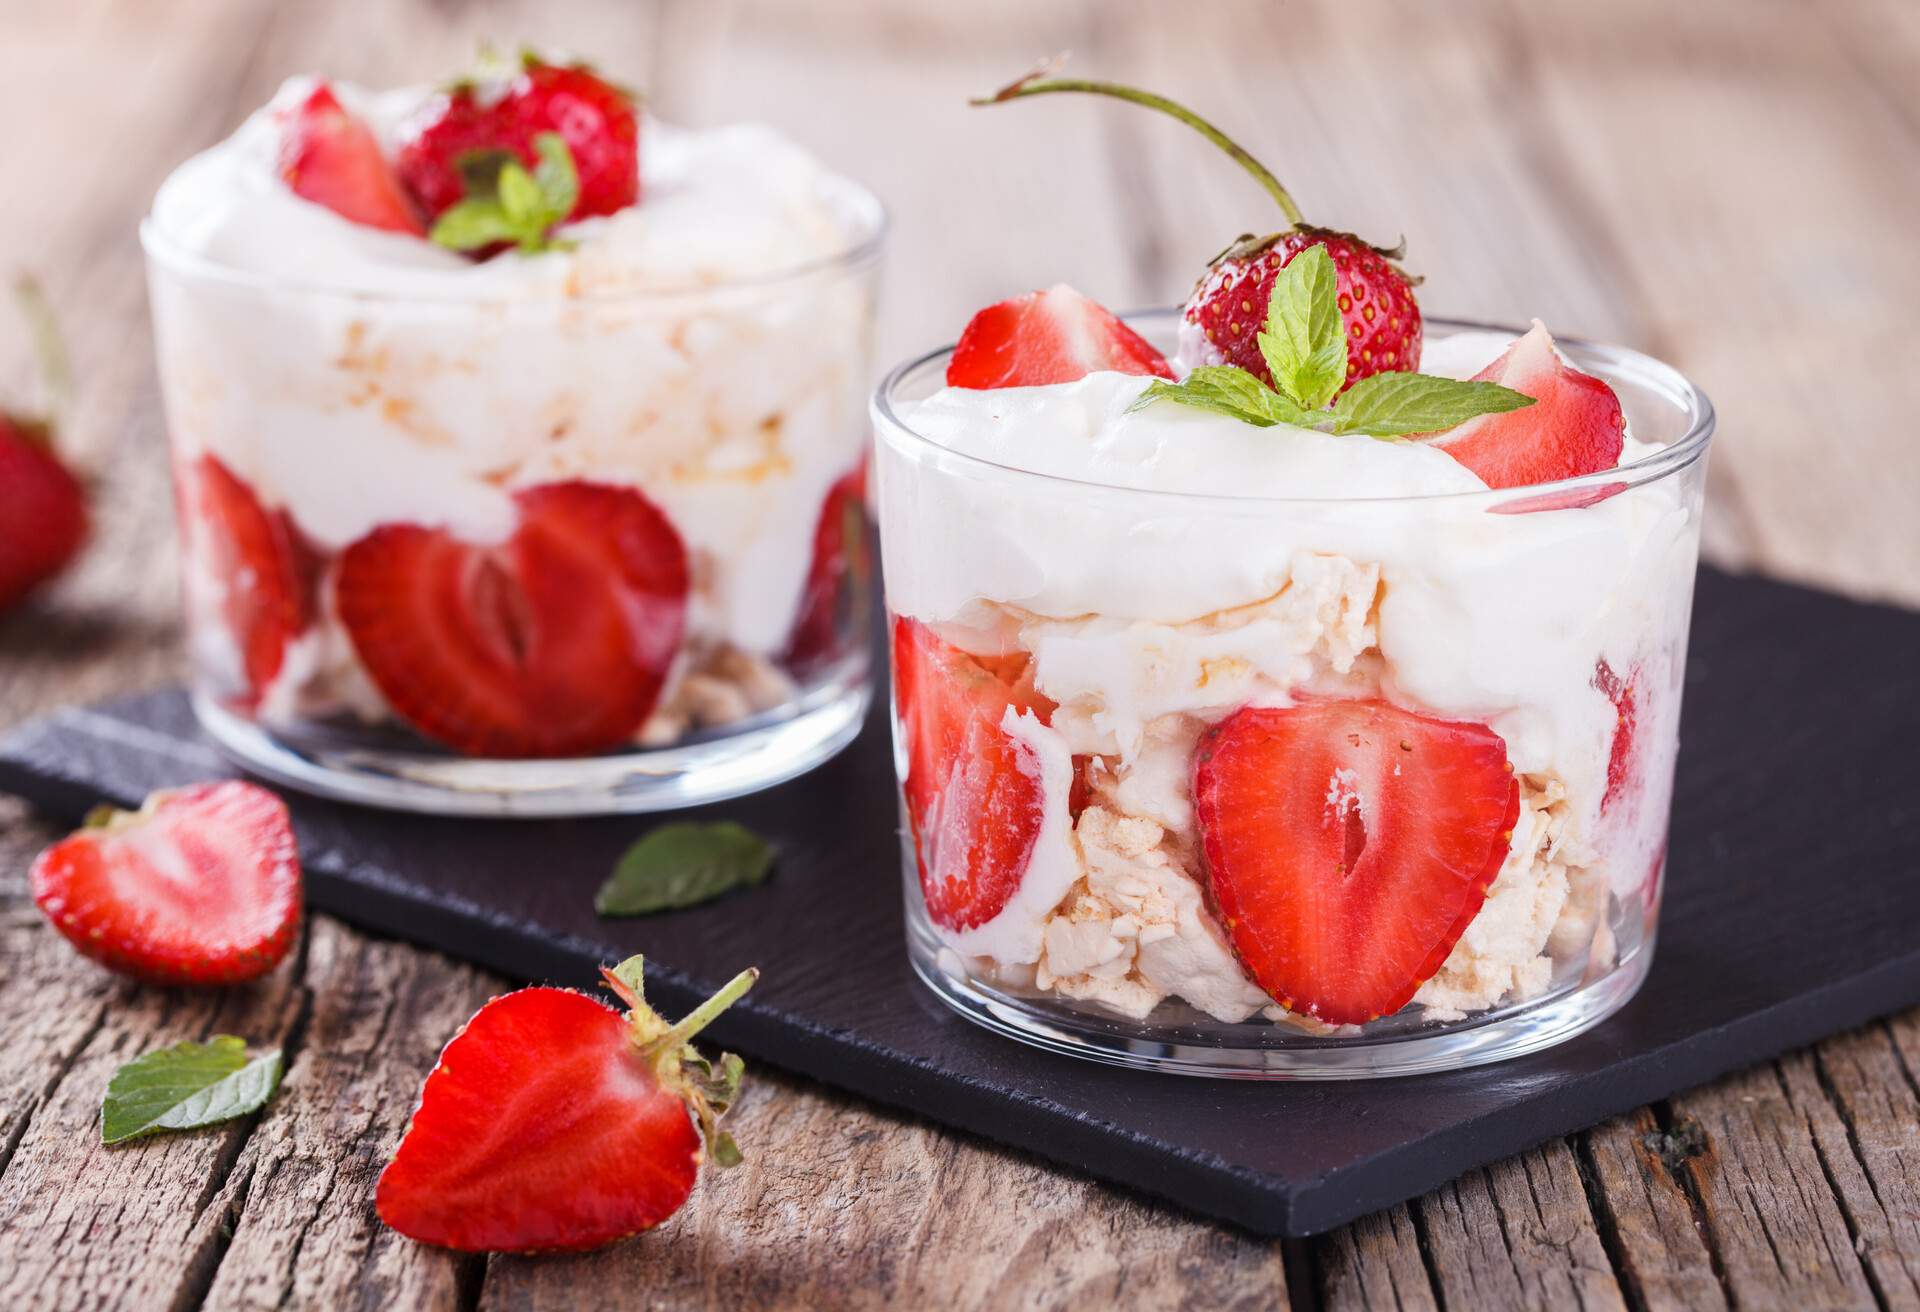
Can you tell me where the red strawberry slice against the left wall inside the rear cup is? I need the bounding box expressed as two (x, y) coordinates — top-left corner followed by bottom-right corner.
(180, 455), (321, 705)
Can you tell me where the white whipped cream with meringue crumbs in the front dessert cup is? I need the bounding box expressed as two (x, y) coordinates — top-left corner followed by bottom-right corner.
(877, 332), (1699, 1020)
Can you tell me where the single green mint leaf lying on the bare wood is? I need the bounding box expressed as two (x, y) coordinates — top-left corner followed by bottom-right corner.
(100, 1033), (280, 1143)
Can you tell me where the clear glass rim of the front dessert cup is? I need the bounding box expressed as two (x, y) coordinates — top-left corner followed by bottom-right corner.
(868, 305), (1715, 513)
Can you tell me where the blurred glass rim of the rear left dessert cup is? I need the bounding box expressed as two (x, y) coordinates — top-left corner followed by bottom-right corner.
(138, 173), (893, 307)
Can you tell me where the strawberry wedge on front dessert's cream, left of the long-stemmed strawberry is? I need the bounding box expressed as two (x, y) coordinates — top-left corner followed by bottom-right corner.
(947, 282), (1173, 388)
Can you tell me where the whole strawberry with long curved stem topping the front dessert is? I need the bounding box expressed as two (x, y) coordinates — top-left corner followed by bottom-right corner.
(973, 65), (1421, 386)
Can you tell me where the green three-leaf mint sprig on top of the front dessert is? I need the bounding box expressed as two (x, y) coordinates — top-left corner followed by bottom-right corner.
(1131, 246), (1534, 440)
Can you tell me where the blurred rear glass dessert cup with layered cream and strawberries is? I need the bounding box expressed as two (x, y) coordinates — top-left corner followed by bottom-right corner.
(142, 194), (885, 814)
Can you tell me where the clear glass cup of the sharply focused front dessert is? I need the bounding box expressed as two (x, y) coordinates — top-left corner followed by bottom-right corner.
(874, 311), (1715, 1080)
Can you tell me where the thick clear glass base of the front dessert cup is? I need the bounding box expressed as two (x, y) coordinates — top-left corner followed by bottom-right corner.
(908, 916), (1653, 1080)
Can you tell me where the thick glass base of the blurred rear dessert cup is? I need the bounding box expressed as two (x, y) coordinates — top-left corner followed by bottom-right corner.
(194, 678), (870, 816)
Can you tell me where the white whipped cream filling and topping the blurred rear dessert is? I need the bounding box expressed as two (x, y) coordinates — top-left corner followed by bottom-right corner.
(148, 79), (881, 729)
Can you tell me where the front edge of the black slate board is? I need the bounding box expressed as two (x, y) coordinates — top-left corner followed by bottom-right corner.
(0, 720), (1920, 1237)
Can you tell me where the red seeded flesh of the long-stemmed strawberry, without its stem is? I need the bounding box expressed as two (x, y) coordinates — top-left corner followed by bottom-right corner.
(1187, 227), (1421, 386)
